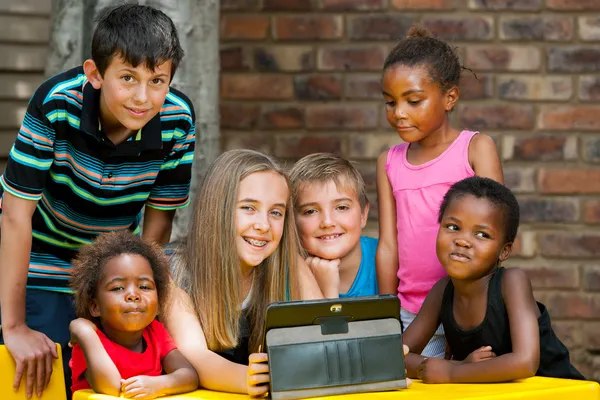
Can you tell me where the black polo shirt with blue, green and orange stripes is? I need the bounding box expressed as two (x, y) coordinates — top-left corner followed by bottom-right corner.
(0, 67), (195, 292)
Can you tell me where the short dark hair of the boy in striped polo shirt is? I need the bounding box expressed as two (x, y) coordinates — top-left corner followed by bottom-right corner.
(92, 4), (183, 79)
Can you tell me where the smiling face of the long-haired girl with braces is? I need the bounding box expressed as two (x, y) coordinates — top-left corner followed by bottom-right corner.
(235, 171), (290, 275)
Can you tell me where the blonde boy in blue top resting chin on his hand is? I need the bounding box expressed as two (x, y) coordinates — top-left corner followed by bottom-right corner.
(290, 153), (377, 298)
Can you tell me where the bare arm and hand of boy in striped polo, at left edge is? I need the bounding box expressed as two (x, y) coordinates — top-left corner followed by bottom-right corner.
(0, 191), (58, 398)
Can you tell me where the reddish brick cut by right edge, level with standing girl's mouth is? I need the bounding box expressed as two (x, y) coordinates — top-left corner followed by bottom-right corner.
(538, 105), (600, 131)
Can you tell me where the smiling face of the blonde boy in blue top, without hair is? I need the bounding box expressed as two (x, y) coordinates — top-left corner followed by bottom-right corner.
(296, 180), (369, 260)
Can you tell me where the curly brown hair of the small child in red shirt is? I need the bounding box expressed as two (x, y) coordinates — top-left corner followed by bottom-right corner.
(70, 231), (170, 321)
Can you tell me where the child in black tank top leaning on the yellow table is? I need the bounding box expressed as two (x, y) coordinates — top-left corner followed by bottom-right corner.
(404, 177), (585, 383)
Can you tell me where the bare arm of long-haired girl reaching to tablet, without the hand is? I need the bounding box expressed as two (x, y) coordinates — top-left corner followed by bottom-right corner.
(162, 288), (248, 393)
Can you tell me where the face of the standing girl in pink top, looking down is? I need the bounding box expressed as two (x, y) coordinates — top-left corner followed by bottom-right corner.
(382, 64), (458, 143)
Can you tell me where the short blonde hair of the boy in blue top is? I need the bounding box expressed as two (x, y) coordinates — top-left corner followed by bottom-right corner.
(290, 153), (369, 210)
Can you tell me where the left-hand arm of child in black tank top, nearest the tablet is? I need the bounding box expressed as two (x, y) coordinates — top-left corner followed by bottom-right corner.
(402, 277), (449, 378)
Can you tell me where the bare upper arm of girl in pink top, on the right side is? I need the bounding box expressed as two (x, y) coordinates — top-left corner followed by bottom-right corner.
(469, 133), (504, 183)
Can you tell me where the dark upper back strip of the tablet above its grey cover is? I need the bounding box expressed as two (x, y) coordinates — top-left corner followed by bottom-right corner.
(265, 294), (400, 336)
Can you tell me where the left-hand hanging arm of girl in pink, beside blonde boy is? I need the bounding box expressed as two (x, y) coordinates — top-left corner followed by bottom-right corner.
(376, 151), (398, 294)
